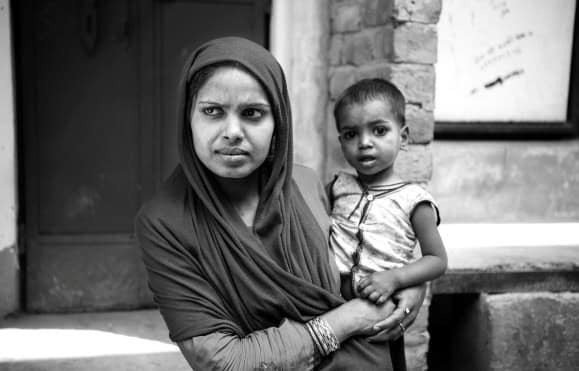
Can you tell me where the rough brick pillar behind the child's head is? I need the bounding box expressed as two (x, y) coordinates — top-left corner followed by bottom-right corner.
(324, 0), (441, 370)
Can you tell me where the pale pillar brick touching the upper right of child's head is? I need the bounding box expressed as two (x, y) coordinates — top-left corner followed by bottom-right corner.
(391, 63), (435, 111)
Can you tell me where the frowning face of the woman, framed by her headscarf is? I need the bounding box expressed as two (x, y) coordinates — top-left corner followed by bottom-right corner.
(191, 67), (275, 179)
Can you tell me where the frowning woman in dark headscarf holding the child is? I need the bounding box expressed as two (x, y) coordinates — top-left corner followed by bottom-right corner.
(136, 37), (424, 370)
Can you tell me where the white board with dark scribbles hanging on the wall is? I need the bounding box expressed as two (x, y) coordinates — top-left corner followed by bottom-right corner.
(434, 0), (575, 122)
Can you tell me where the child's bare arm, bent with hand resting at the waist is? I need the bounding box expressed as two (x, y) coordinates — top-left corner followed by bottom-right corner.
(358, 202), (447, 304)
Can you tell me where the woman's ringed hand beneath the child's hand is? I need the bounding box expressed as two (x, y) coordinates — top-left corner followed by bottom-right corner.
(374, 284), (426, 340)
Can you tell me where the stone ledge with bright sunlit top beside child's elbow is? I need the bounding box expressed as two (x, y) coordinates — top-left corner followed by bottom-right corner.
(433, 223), (579, 294)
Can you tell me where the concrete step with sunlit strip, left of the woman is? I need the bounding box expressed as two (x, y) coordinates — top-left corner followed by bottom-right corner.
(0, 310), (190, 371)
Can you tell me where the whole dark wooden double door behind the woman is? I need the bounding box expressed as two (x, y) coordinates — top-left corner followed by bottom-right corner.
(13, 0), (267, 311)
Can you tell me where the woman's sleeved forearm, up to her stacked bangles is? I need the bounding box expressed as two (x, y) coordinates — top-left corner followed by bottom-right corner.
(179, 320), (317, 370)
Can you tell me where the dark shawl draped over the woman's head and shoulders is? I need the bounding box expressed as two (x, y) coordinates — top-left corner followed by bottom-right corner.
(136, 37), (390, 370)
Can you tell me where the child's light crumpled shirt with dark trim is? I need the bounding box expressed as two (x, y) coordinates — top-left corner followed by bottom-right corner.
(330, 172), (440, 276)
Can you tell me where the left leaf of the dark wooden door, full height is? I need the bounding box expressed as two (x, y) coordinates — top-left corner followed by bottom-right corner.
(16, 0), (153, 311)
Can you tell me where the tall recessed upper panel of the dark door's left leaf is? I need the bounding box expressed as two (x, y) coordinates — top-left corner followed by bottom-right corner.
(33, 1), (140, 235)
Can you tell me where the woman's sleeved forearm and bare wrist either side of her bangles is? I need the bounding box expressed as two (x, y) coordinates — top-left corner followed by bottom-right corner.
(179, 299), (402, 370)
